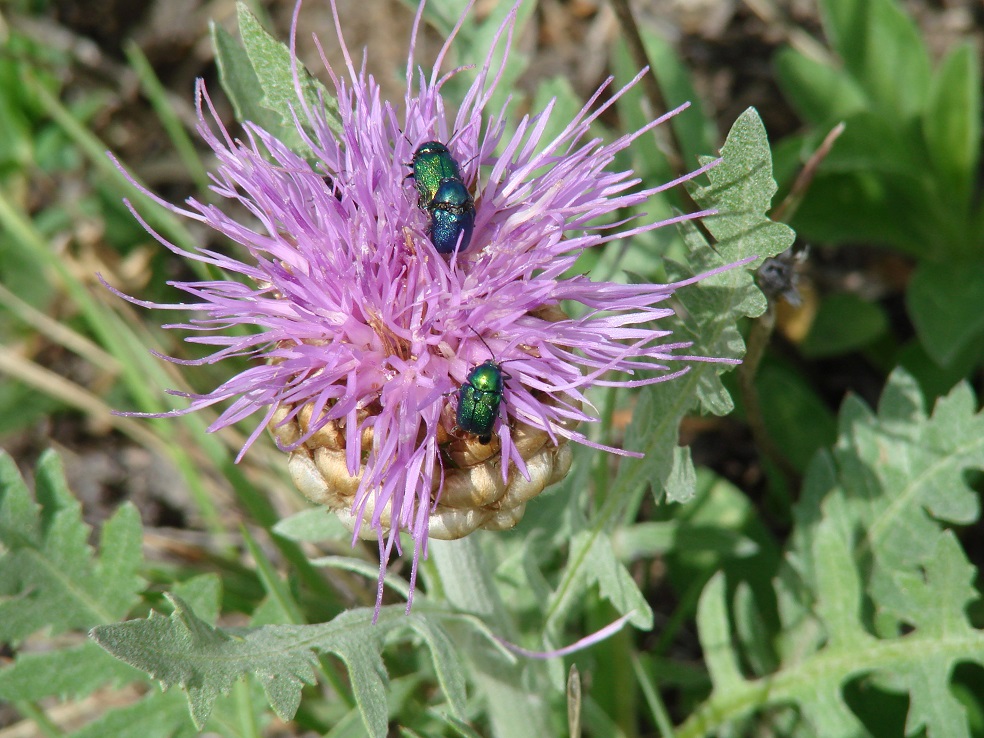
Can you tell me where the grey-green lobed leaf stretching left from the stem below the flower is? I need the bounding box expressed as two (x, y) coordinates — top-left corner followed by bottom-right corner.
(91, 595), (476, 736)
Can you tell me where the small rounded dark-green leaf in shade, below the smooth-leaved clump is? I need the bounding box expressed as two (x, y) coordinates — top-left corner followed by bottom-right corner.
(800, 293), (888, 359)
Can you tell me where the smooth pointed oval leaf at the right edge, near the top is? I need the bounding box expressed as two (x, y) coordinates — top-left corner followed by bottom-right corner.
(923, 42), (981, 208)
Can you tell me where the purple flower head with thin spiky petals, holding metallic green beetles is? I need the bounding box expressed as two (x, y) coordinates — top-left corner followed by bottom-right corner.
(109, 4), (736, 610)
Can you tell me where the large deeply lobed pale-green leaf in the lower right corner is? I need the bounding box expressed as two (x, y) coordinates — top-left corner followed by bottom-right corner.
(676, 372), (984, 737)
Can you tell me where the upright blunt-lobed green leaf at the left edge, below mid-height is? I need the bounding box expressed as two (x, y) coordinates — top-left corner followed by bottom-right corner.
(0, 452), (143, 642)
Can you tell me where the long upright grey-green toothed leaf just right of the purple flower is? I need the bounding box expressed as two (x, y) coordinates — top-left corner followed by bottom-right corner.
(547, 110), (793, 648)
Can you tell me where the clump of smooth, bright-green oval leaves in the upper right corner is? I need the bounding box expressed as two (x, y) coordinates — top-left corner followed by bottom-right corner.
(775, 0), (984, 367)
